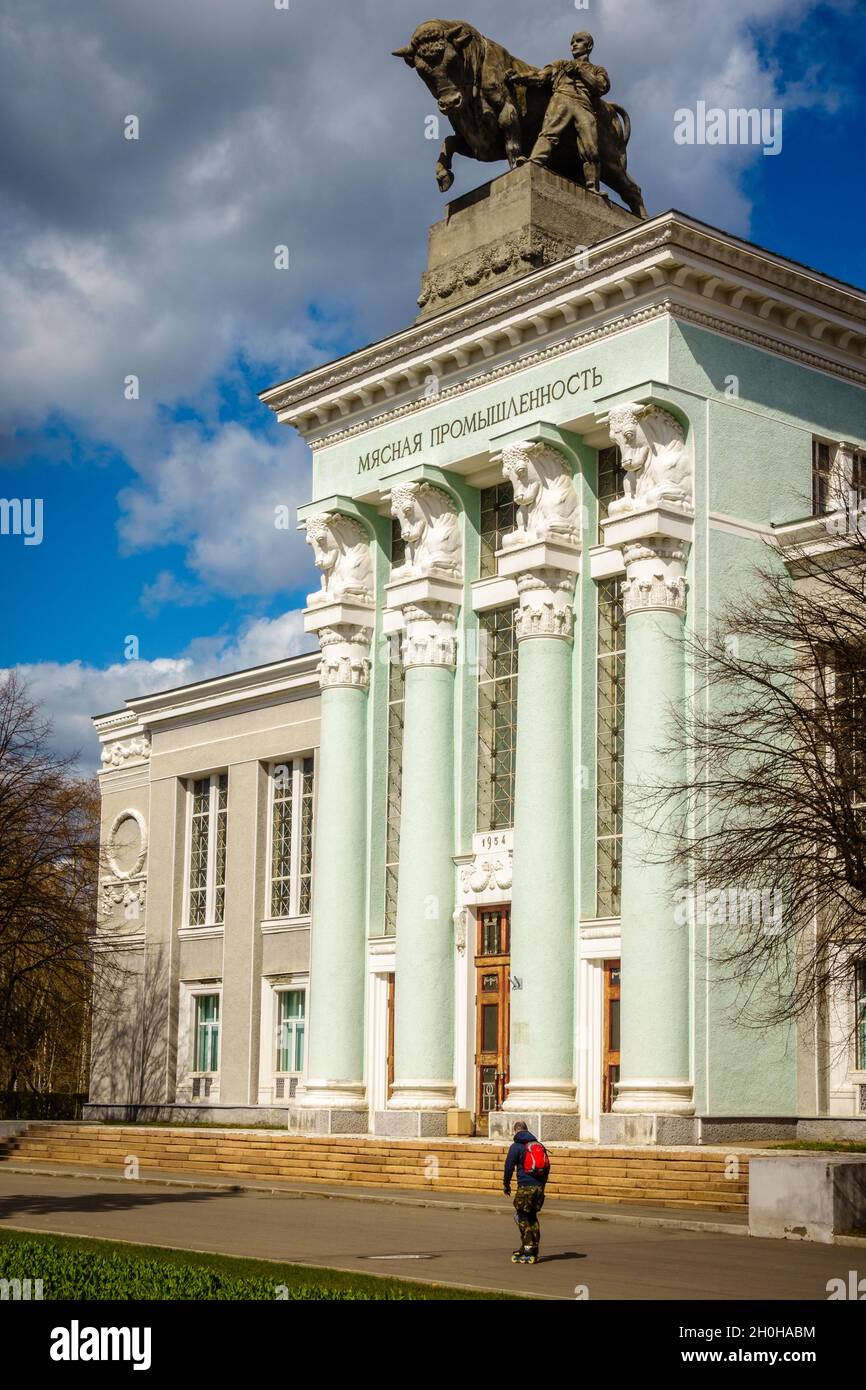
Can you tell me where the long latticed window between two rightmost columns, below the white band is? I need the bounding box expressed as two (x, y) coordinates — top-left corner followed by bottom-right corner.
(595, 578), (626, 917)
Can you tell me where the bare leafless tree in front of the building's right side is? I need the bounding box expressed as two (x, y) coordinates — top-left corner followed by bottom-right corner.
(647, 510), (866, 1026)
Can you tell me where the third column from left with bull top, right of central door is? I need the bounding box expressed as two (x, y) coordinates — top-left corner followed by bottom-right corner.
(491, 439), (581, 1138)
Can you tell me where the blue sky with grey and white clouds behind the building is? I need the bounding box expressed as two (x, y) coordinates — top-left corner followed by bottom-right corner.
(0, 0), (866, 766)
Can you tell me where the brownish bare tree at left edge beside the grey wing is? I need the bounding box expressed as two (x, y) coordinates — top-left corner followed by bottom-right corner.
(0, 673), (100, 1093)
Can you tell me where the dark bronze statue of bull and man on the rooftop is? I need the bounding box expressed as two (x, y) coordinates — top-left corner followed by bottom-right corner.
(395, 19), (648, 217)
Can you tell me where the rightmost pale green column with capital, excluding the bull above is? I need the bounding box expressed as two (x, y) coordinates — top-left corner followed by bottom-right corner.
(602, 509), (694, 1123)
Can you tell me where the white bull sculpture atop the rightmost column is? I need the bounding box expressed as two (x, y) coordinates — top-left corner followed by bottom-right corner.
(607, 402), (692, 517)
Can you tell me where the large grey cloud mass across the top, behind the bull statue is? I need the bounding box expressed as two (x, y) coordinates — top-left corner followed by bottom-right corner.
(0, 0), (833, 448)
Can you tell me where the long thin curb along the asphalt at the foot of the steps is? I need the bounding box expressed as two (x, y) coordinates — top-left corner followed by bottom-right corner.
(0, 1162), (750, 1244)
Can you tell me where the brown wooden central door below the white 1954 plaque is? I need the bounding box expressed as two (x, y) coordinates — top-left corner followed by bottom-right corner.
(475, 906), (512, 1134)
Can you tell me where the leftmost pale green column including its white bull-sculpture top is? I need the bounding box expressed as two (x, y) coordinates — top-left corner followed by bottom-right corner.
(289, 513), (374, 1134)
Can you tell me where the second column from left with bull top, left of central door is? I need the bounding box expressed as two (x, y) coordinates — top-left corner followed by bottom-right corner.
(375, 481), (463, 1138)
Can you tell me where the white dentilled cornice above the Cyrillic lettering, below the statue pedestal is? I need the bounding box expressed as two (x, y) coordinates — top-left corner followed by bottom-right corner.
(261, 213), (866, 446)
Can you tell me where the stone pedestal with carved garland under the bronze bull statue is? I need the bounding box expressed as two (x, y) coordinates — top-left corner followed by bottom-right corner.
(418, 164), (641, 320)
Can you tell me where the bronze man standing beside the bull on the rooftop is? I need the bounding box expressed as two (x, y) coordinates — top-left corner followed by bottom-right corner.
(507, 31), (610, 193)
